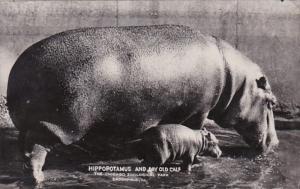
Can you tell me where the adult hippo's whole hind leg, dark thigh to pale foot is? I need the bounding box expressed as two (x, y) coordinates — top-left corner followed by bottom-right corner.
(19, 124), (58, 183)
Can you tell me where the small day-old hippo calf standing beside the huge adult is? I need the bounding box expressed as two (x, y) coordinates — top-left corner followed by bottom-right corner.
(135, 124), (222, 172)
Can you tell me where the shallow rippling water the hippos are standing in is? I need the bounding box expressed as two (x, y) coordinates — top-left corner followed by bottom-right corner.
(0, 123), (300, 189)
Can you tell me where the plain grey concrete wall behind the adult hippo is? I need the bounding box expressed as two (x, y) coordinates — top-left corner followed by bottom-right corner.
(0, 0), (300, 115)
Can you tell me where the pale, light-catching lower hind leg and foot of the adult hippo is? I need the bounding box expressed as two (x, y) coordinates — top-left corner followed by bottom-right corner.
(24, 144), (49, 184)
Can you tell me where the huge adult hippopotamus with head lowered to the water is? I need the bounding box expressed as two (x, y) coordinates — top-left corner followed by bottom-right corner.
(7, 25), (278, 182)
